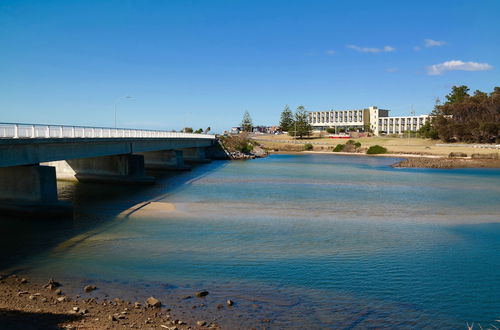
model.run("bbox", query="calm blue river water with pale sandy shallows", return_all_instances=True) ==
[0,154,500,329]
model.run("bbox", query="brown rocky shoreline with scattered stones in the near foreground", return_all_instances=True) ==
[0,275,223,330]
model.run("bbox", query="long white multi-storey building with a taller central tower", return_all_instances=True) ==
[308,107,429,135]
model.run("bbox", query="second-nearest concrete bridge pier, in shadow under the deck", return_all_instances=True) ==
[67,154,155,183]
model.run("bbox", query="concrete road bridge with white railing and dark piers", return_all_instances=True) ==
[0,123,227,215]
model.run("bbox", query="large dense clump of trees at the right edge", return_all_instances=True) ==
[426,86,500,143]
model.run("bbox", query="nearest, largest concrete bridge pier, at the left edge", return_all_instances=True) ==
[0,165,72,216]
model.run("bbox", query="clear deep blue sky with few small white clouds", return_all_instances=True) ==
[0,0,500,132]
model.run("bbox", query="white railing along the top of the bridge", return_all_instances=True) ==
[0,123,215,139]
